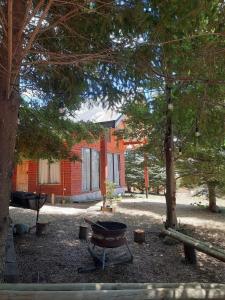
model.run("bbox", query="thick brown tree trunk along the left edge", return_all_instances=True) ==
[0,0,27,282]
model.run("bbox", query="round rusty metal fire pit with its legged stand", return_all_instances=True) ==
[86,219,133,269]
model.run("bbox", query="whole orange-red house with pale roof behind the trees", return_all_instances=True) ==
[13,107,125,201]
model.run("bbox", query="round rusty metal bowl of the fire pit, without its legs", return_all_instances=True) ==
[91,221,127,248]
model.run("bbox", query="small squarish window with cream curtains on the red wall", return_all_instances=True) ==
[39,159,60,184]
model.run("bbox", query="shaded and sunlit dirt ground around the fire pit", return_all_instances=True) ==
[10,191,225,283]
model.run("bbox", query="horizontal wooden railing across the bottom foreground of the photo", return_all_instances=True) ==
[0,283,225,300]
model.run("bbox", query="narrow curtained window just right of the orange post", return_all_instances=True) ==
[107,153,120,186]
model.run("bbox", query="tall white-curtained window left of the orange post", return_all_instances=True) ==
[82,148,99,192]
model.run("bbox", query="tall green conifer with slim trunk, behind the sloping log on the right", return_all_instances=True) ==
[122,1,225,227]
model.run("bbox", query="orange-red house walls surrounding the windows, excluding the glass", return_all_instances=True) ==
[12,124,125,200]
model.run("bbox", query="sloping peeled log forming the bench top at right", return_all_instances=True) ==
[164,228,225,262]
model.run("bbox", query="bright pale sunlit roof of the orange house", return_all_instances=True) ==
[75,104,123,127]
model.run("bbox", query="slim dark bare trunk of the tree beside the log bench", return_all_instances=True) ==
[164,85,177,228]
